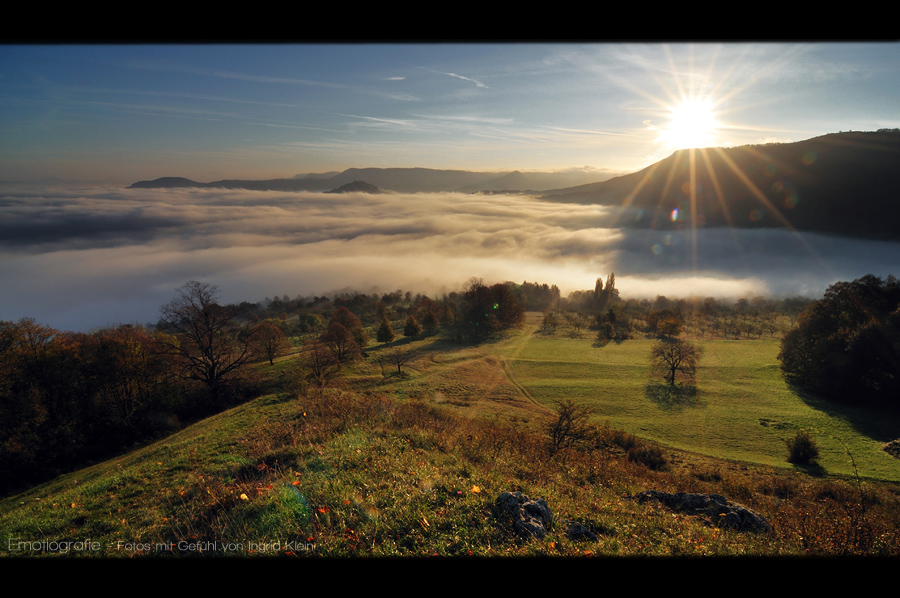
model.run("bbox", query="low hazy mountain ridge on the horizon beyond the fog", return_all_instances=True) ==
[129,168,612,193]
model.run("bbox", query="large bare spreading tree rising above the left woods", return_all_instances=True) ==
[159,280,254,401]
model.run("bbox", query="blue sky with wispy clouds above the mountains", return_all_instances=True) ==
[7,42,900,184]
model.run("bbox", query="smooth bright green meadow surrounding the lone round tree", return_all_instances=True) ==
[510,335,900,481]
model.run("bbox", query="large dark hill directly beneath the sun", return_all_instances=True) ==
[542,130,900,240]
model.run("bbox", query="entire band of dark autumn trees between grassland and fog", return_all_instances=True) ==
[8,274,880,493]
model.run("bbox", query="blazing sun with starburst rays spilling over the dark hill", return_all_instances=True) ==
[600,46,832,282]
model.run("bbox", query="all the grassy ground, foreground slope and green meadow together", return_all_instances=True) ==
[0,314,900,558]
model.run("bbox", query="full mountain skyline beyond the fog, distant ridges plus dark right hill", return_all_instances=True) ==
[130,129,900,241]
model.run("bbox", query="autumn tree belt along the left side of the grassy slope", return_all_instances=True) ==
[0,279,525,493]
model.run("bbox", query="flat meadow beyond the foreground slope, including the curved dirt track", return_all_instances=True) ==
[359,314,900,481]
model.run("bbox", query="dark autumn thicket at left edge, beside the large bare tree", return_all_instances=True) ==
[0,318,180,491]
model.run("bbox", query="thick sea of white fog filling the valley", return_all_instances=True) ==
[0,186,900,331]
